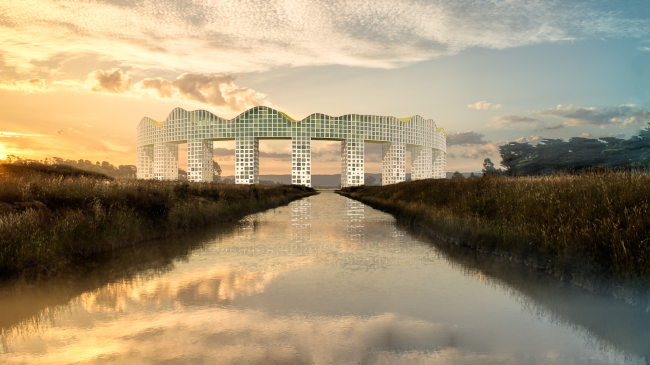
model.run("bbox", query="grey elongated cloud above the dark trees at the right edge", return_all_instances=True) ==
[534,104,650,128]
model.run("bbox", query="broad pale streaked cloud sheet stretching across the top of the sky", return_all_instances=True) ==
[0,0,650,73]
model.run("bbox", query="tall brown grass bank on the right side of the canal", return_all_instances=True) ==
[341,171,650,280]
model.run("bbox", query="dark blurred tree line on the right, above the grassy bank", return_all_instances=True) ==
[483,123,650,176]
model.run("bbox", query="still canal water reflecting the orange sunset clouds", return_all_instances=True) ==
[0,193,650,364]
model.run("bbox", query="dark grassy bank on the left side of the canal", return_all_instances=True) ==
[0,165,316,280]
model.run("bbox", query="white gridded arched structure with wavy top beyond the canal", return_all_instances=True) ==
[137,106,446,187]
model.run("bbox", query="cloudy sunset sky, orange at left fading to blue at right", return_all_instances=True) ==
[0,0,650,175]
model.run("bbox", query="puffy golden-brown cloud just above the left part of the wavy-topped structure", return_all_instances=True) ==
[136,73,267,111]
